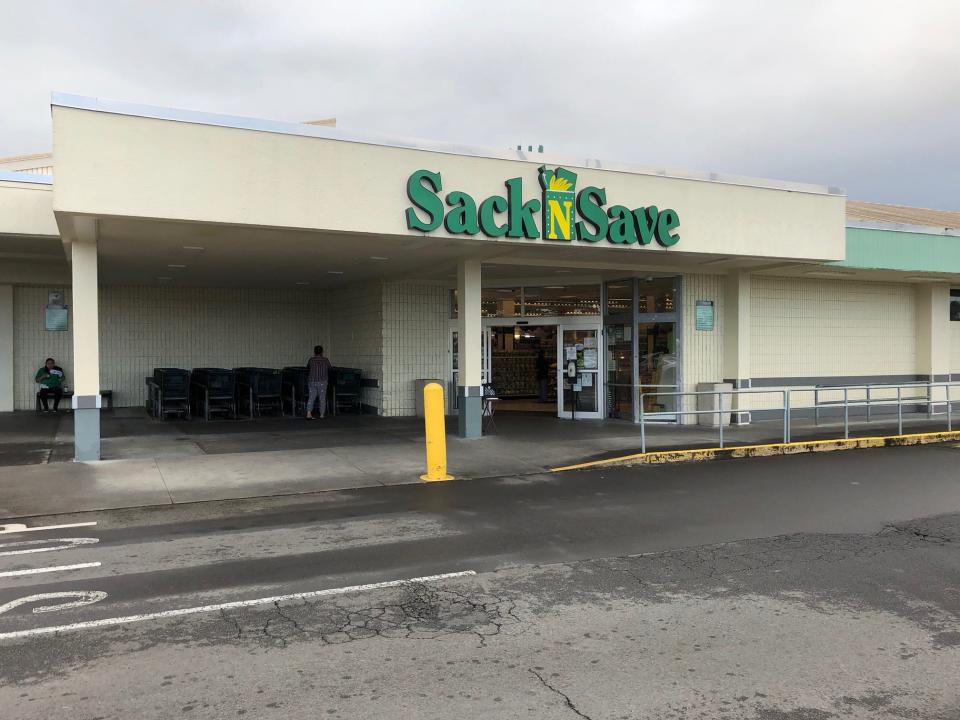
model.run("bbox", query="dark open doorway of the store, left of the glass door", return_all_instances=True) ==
[488,323,557,414]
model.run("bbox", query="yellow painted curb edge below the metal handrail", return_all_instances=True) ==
[550,430,960,472]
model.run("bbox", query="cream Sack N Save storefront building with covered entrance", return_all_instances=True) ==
[0,95,960,459]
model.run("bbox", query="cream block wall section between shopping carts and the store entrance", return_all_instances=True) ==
[383,281,450,416]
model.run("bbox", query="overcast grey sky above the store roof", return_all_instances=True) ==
[0,0,960,209]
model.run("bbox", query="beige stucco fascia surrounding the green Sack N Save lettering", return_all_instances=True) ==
[53,106,845,259]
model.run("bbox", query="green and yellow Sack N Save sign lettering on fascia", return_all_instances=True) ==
[405,166,680,247]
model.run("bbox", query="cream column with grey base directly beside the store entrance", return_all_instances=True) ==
[457,260,483,438]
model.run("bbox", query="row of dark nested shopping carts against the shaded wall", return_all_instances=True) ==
[145,366,362,420]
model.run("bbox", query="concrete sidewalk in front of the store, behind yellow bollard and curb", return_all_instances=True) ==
[0,408,943,518]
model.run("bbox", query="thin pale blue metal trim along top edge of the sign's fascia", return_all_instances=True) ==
[50,92,846,196]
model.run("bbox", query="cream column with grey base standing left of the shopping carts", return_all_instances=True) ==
[70,242,100,461]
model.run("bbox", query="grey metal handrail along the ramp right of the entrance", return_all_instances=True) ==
[639,382,960,452]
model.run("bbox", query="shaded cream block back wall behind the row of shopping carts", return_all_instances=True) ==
[14,286,329,409]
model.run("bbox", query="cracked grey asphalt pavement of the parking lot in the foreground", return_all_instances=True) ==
[0,446,960,720]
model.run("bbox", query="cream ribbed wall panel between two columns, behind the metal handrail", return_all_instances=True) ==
[750,275,916,378]
